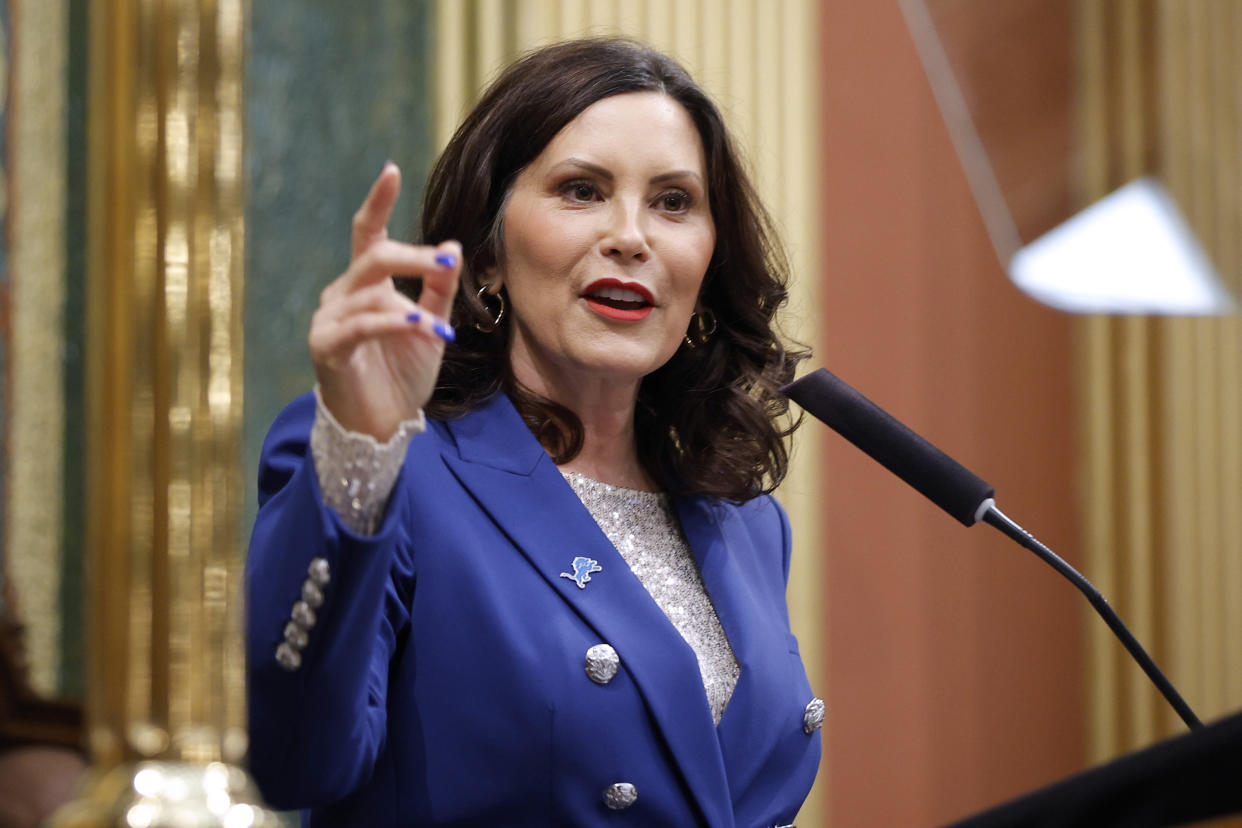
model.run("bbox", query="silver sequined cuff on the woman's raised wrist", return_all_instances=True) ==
[311,385,427,535]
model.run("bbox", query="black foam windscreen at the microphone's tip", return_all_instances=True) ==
[781,369,996,526]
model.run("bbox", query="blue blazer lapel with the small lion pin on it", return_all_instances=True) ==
[445,395,733,826]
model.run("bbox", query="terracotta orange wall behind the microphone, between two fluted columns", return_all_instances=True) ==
[807,0,1087,828]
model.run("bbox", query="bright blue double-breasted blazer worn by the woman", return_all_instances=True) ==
[246,395,820,828]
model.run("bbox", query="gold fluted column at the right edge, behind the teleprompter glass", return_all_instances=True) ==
[1078,0,1242,761]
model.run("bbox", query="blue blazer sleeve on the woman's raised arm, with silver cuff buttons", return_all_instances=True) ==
[246,395,414,808]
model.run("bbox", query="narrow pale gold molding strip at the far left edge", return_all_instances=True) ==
[4,0,68,696]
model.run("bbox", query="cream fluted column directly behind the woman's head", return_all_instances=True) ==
[433,0,831,826]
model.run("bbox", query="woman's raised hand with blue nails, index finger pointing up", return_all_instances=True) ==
[308,161,462,441]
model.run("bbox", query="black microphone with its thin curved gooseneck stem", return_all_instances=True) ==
[781,367,1203,730]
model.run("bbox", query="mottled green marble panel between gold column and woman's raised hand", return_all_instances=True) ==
[245,0,433,531]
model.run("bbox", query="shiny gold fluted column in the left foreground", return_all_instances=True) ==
[55,0,272,828]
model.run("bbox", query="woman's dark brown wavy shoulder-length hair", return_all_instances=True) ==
[421,38,807,500]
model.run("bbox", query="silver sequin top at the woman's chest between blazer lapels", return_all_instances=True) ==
[561,472,740,724]
